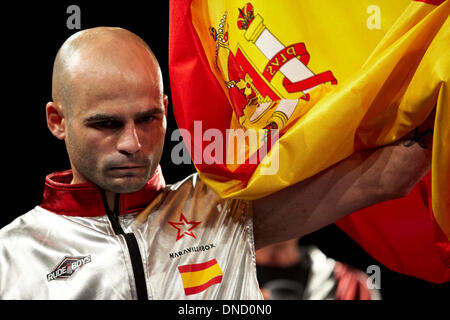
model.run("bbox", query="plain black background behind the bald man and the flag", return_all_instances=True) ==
[0,1,450,300]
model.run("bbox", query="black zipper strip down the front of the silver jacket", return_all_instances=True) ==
[100,190,148,300]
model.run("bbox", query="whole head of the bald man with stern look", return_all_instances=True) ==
[46,27,168,193]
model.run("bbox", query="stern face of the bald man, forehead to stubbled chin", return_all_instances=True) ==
[65,55,167,193]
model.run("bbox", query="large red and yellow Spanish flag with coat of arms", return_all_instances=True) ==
[169,0,450,282]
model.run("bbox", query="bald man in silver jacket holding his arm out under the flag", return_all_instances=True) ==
[0,27,431,299]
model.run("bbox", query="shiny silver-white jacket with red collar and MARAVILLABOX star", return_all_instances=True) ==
[0,171,262,299]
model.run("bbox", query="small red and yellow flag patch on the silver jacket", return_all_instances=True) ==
[178,259,222,296]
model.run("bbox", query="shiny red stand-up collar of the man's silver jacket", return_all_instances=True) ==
[41,166,166,217]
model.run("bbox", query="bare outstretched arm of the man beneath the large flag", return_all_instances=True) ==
[253,115,434,249]
